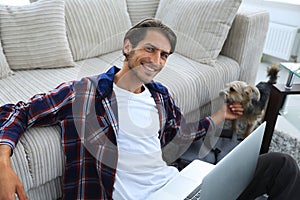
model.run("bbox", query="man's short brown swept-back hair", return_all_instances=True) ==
[123,18,177,54]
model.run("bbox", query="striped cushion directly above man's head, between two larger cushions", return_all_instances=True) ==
[127,0,159,24]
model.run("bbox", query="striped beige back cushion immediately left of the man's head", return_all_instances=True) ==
[65,0,131,61]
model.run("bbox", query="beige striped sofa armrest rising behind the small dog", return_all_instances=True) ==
[221,7,269,84]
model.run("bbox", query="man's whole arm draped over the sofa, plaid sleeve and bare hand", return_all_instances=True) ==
[0,80,73,200]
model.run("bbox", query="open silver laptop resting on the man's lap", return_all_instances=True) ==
[148,122,266,200]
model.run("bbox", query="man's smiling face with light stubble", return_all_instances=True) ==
[128,30,171,83]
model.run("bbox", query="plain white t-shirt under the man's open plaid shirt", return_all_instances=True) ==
[113,84,178,200]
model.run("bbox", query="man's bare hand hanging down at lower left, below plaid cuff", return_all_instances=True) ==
[0,145,28,200]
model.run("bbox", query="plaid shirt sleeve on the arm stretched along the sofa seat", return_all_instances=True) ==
[0,82,74,150]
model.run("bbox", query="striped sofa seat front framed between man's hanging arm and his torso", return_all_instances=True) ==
[20,126,65,187]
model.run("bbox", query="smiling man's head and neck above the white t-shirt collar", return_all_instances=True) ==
[114,24,176,93]
